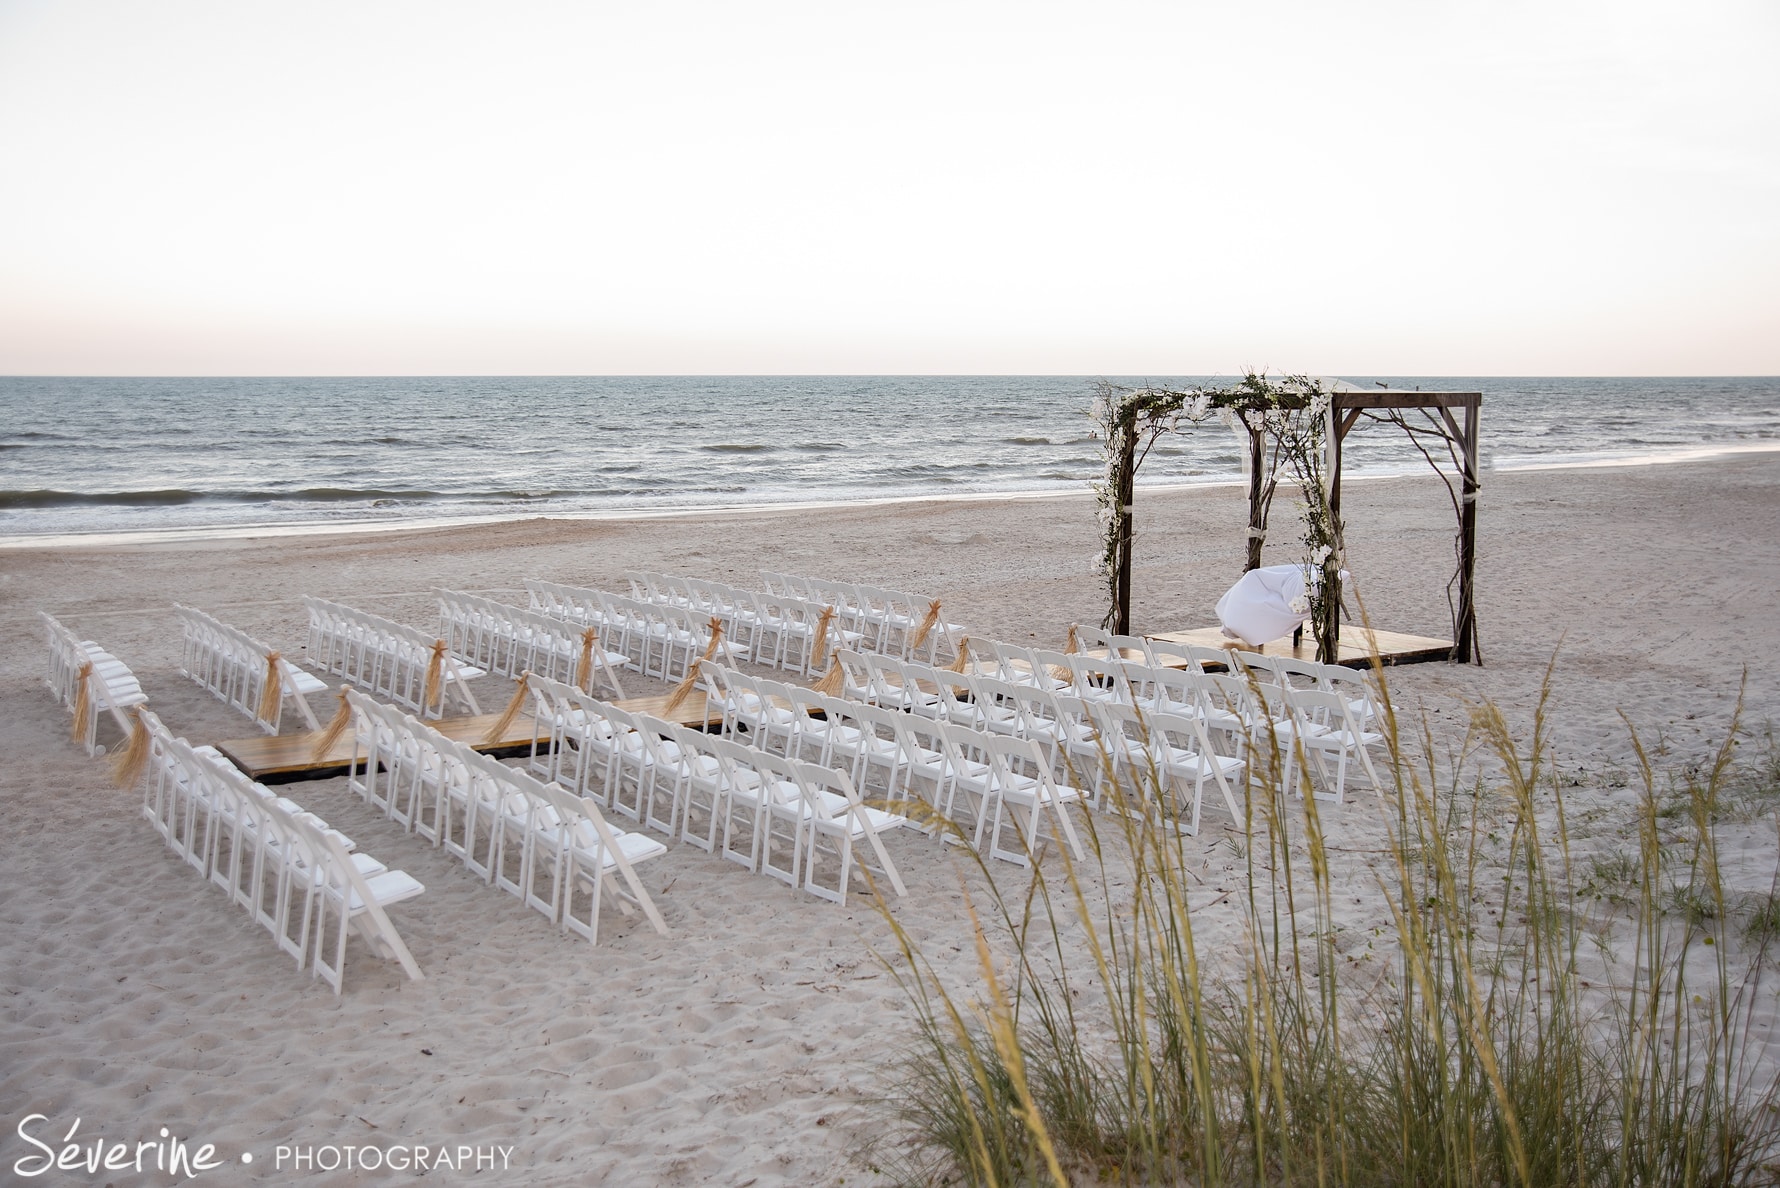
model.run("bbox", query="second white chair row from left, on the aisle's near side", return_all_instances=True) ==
[347,691,668,944]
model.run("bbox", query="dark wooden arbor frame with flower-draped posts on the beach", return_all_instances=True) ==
[1098,376,1483,664]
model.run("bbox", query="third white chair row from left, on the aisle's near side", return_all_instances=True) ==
[529,663,906,903]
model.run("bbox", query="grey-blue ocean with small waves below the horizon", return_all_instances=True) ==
[0,376,1780,538]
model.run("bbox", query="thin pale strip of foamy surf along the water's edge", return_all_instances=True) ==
[0,442,1780,552]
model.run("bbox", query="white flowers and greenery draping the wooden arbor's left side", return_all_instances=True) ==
[1088,372,1346,663]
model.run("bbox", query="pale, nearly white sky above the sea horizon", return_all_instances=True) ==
[0,0,1780,376]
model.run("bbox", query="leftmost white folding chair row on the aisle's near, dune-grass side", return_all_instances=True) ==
[141,711,425,996]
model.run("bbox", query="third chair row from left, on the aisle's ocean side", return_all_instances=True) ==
[303,595,482,718]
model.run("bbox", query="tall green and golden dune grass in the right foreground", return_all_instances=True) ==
[876,666,1780,1186]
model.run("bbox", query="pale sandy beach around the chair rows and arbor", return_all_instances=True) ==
[0,452,1780,1184]
